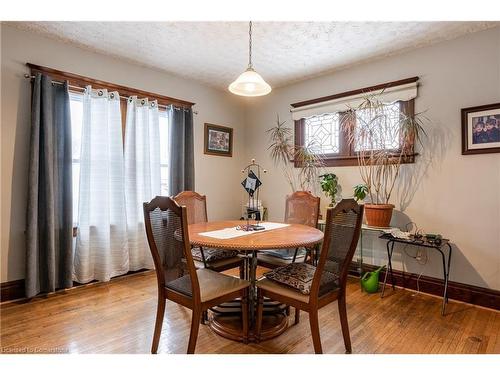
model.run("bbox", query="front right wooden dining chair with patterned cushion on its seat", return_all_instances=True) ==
[256,199,363,354]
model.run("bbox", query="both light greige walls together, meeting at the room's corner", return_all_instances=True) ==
[0,24,500,290]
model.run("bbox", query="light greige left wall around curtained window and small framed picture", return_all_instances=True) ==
[0,24,246,282]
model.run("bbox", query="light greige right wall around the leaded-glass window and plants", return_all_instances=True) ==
[246,28,500,290]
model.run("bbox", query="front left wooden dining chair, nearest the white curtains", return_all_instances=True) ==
[144,197,250,354]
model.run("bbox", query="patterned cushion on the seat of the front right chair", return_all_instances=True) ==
[264,263,339,295]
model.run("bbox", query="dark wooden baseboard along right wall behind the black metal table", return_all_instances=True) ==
[351,263,500,310]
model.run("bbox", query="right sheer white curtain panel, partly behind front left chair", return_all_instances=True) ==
[125,97,161,271]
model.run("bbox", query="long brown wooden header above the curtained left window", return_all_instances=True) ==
[26,63,195,108]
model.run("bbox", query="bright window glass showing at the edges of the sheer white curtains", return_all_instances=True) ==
[69,92,172,227]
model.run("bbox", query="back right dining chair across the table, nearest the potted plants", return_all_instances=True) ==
[257,191,320,269]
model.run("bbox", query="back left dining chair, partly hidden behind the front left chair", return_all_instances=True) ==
[174,191,245,279]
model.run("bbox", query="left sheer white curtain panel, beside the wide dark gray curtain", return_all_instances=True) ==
[74,86,129,283]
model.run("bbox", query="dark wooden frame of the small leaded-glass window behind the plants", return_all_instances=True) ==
[291,77,418,168]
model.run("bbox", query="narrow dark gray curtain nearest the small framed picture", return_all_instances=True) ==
[168,107,194,196]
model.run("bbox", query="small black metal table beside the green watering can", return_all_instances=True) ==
[379,234,452,315]
